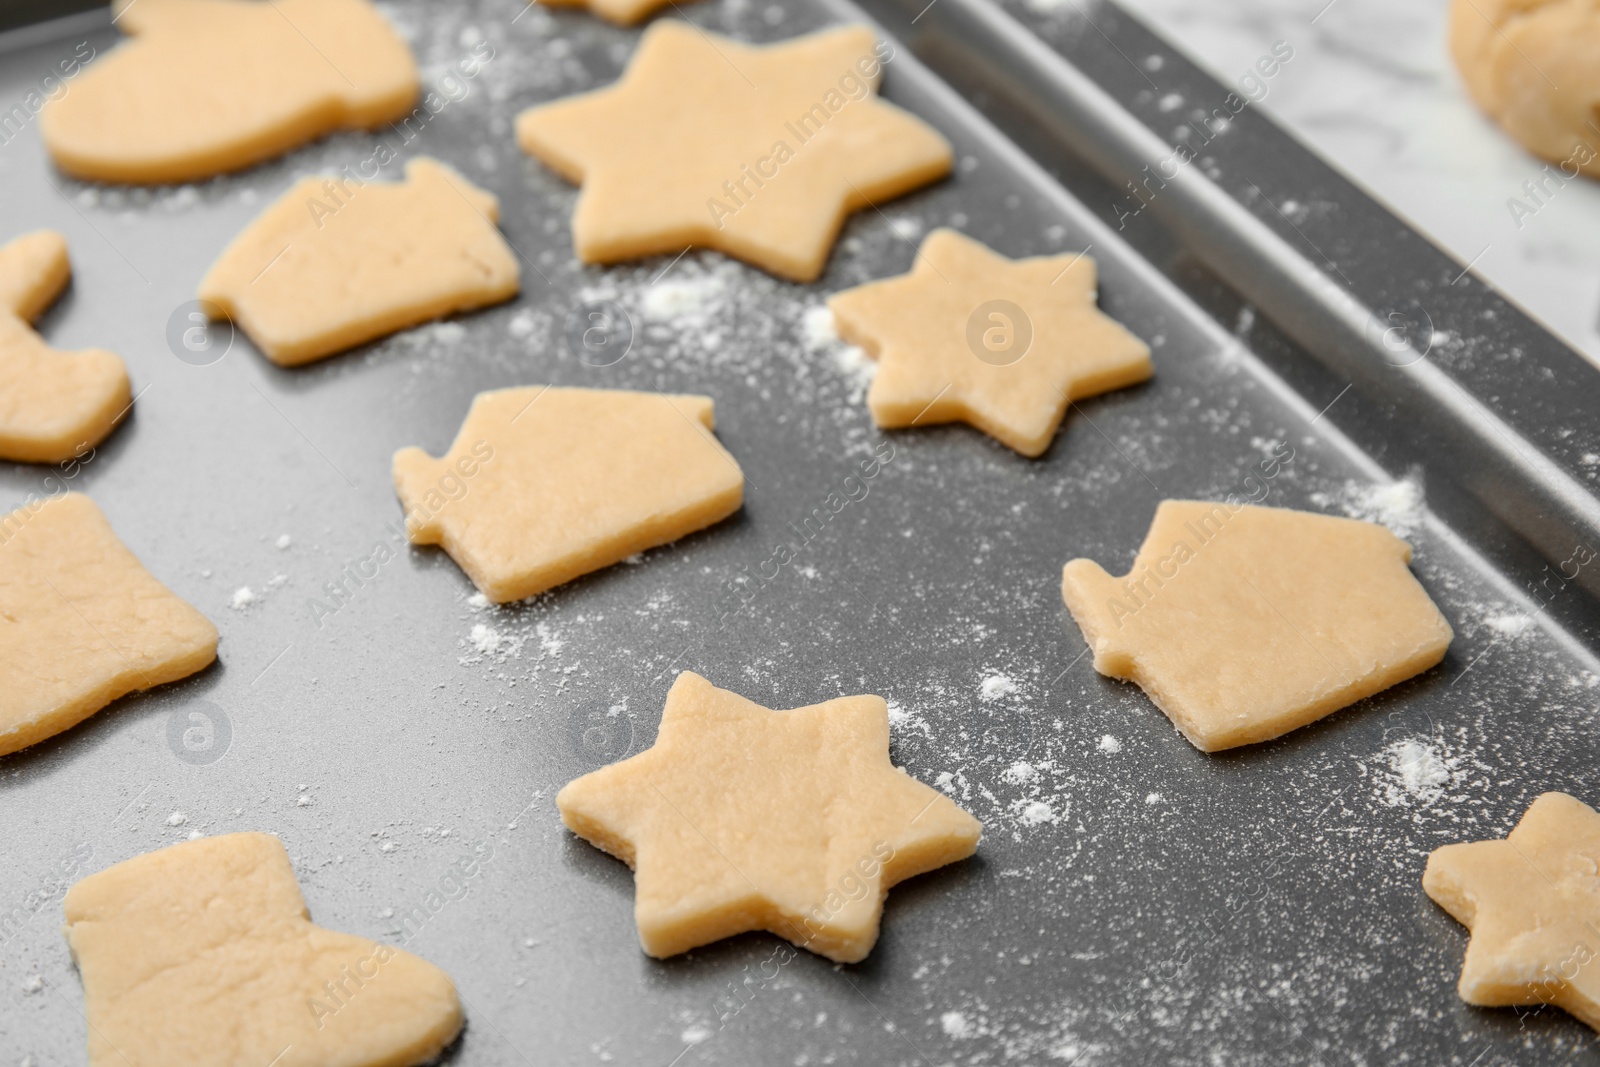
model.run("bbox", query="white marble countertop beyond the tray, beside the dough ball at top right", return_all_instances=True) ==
[1122,0,1600,363]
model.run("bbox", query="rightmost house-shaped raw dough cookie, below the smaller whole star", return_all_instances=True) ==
[1061,501,1451,752]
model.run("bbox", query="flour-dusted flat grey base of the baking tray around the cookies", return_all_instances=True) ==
[0,0,1600,1067]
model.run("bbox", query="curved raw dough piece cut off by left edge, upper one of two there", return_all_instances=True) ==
[0,230,133,462]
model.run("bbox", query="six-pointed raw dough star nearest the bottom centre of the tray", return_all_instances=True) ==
[555,672,982,963]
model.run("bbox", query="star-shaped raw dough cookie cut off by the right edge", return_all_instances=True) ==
[1422,793,1600,1030]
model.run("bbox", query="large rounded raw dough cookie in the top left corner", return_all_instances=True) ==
[38,0,418,182]
